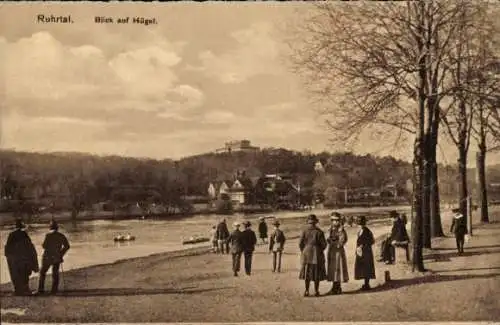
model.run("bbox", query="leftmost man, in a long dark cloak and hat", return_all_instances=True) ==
[5,220,38,296]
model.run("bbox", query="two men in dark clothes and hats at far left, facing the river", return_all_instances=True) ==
[5,220,70,296]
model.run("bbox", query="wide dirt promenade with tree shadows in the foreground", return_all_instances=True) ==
[1,210,500,322]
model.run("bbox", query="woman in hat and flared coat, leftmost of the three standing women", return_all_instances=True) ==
[299,214,327,297]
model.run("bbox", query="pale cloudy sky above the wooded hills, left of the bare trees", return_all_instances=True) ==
[0,2,500,163]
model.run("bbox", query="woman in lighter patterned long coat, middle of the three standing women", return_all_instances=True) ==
[326,212,349,295]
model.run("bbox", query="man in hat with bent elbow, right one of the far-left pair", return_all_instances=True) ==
[38,220,70,294]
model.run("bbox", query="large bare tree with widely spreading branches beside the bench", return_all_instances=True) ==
[292,1,478,270]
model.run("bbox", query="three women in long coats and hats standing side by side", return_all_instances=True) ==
[299,212,375,297]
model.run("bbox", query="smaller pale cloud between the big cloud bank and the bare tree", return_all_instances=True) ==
[194,23,280,83]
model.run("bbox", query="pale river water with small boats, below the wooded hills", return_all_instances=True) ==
[0,207,408,283]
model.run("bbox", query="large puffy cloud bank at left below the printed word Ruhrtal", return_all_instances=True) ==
[0,32,204,122]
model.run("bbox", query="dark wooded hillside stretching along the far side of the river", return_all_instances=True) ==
[0,148,500,214]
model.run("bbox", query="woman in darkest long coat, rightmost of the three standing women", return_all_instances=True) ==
[354,216,375,290]
